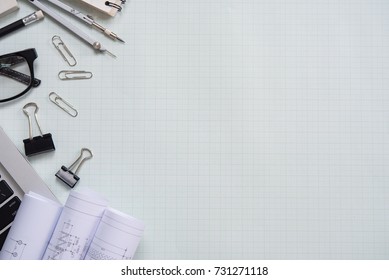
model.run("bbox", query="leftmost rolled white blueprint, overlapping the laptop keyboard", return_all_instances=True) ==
[0,192,62,260]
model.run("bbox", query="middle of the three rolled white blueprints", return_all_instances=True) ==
[43,189,108,260]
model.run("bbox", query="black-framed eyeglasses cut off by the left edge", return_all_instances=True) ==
[0,48,41,103]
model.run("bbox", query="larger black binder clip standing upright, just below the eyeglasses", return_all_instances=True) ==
[23,102,55,156]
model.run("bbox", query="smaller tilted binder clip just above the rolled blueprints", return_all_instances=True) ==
[55,148,93,188]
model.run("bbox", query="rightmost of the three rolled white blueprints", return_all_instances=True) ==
[85,208,145,260]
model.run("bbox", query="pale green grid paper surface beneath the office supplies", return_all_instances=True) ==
[0,0,389,259]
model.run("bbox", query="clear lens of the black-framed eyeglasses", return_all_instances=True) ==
[0,55,31,100]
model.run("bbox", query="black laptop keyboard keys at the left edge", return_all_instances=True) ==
[0,175,21,250]
